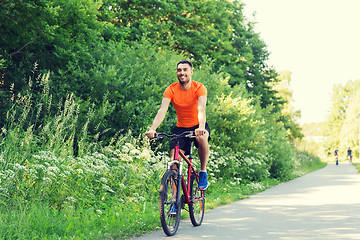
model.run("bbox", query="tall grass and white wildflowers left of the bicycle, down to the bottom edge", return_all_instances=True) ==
[0,74,162,239]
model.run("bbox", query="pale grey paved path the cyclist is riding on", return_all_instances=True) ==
[134,163,360,240]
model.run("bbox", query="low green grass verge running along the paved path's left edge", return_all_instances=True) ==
[0,159,323,239]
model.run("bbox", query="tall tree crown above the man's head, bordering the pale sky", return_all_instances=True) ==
[100,0,282,110]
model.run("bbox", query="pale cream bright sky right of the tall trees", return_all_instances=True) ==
[242,0,360,124]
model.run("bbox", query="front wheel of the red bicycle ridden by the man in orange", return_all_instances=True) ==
[159,170,181,236]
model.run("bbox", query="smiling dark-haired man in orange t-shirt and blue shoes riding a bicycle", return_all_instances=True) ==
[146,60,210,189]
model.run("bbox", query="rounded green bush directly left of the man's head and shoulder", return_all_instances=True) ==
[60,40,180,138]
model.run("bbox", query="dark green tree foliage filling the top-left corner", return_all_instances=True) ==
[0,0,107,125]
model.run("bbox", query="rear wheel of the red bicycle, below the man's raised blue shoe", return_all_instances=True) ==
[189,174,205,227]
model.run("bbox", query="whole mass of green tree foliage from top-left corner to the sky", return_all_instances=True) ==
[0,0,296,147]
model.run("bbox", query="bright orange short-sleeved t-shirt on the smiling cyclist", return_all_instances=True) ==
[164,81,207,128]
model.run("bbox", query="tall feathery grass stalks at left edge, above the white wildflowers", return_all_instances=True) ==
[0,73,78,169]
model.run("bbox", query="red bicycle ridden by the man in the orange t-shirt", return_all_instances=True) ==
[156,131,205,236]
